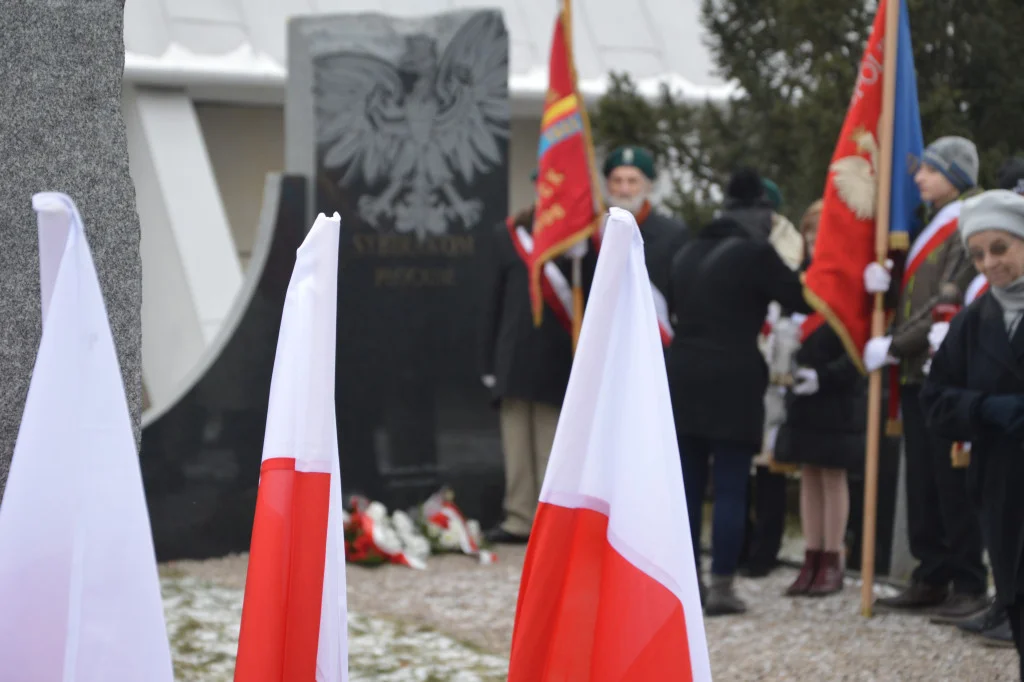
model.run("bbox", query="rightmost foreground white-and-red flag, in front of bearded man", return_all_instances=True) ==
[508,208,711,682]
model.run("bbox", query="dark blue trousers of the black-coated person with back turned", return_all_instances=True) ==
[679,435,754,576]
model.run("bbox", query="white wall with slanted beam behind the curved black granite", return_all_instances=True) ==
[122,86,242,404]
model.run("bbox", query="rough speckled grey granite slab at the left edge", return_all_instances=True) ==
[0,0,142,497]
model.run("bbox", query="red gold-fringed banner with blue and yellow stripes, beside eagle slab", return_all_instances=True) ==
[529,0,604,325]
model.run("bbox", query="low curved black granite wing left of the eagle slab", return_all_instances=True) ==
[141,176,309,561]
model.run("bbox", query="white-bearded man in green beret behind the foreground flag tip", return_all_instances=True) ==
[602,145,689,348]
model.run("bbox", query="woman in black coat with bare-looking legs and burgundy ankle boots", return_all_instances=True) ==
[775,201,867,596]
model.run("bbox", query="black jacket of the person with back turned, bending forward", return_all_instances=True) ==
[668,219,810,452]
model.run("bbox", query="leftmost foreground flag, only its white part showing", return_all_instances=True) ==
[0,193,174,682]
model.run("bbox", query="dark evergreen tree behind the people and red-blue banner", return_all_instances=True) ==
[593,0,1024,224]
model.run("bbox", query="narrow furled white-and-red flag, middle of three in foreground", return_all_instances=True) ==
[234,213,348,682]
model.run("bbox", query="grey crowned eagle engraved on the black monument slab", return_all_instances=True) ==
[314,12,509,239]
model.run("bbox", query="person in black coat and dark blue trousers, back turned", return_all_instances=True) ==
[667,175,809,615]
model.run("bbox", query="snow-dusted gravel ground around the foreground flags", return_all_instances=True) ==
[164,546,1017,682]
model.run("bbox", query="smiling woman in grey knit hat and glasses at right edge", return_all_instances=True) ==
[921,189,1024,679]
